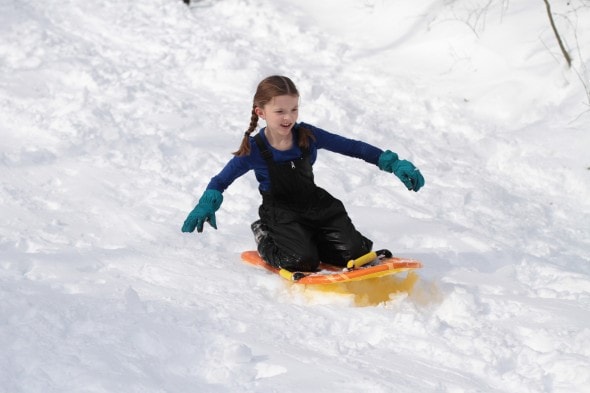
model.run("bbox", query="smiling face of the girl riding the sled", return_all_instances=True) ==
[255,95,299,136]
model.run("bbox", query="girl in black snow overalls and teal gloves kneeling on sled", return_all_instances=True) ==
[182,75,424,271]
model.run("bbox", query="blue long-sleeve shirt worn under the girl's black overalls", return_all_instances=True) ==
[207,123,383,192]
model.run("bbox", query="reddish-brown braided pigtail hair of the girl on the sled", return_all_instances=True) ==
[233,75,315,157]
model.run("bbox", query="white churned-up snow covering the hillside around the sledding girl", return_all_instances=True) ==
[0,0,590,393]
